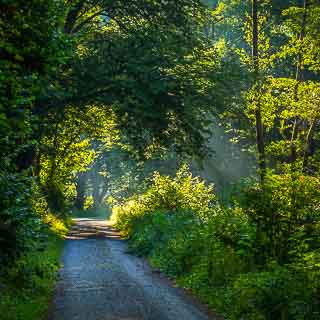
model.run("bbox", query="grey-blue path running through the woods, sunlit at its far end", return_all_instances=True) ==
[49,219,214,320]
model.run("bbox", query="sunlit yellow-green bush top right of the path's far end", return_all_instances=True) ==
[113,166,215,236]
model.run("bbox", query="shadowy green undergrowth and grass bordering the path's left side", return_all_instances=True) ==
[0,175,71,320]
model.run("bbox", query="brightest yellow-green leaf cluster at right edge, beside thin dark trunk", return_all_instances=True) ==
[246,77,320,164]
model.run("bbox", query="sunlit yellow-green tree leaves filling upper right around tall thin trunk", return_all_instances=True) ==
[212,1,319,172]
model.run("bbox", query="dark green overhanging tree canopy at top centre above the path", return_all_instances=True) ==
[62,0,219,156]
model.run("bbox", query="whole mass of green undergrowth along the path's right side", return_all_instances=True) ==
[113,169,320,320]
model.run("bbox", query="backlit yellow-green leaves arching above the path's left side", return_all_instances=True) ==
[40,106,119,209]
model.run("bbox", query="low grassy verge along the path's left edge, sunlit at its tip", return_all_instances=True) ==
[0,220,67,320]
